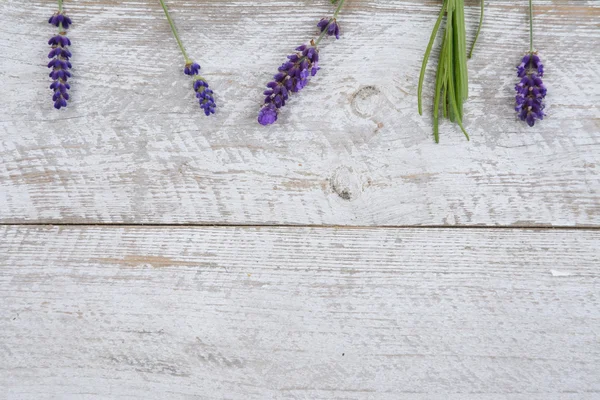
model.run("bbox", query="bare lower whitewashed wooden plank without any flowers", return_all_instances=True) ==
[0,226,600,400]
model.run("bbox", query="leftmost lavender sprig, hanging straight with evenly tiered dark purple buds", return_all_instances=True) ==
[48,0,72,110]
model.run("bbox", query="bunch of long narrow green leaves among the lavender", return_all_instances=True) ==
[418,0,483,143]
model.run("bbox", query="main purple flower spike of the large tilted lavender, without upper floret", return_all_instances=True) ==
[258,44,319,125]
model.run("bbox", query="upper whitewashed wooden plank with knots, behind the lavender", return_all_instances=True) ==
[0,0,600,226]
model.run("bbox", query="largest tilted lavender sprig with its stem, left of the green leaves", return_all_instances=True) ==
[258,0,345,125]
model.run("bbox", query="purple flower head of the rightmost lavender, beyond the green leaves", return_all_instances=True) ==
[515,53,546,126]
